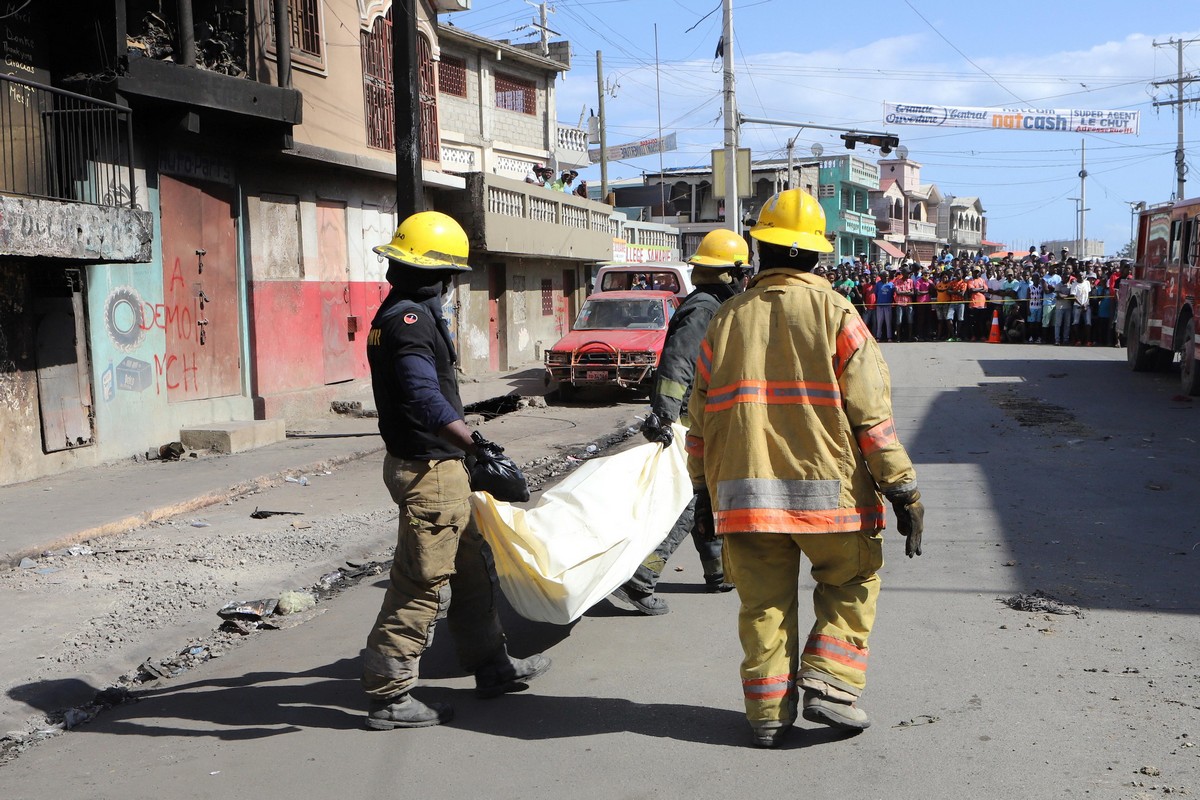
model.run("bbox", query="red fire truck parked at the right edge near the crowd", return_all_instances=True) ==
[1116,198,1200,396]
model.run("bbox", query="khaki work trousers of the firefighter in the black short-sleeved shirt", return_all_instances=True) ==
[362,455,504,698]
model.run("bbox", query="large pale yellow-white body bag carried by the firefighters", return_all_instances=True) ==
[472,426,691,625]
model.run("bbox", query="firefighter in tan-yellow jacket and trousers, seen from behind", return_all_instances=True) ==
[688,190,924,747]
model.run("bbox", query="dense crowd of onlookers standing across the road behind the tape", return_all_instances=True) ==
[814,247,1129,347]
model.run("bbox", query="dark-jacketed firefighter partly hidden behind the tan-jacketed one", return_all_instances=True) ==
[613,228,750,615]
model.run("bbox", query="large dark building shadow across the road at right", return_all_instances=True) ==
[895,348,1200,614]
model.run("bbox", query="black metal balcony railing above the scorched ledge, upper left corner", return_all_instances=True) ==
[0,76,137,207]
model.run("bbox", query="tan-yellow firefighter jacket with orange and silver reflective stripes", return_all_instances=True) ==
[688,269,917,534]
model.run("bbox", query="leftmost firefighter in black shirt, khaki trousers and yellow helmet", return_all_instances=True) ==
[362,211,550,730]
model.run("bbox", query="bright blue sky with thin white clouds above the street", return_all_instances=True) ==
[442,0,1200,253]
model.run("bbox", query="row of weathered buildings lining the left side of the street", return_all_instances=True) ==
[0,0,657,483]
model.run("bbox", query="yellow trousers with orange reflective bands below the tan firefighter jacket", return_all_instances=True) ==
[722,531,883,724]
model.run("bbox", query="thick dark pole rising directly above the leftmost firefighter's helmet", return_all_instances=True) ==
[391,0,422,215]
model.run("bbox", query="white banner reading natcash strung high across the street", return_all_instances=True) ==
[883,103,1141,136]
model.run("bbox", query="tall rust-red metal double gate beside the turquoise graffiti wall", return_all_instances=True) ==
[158,175,241,403]
